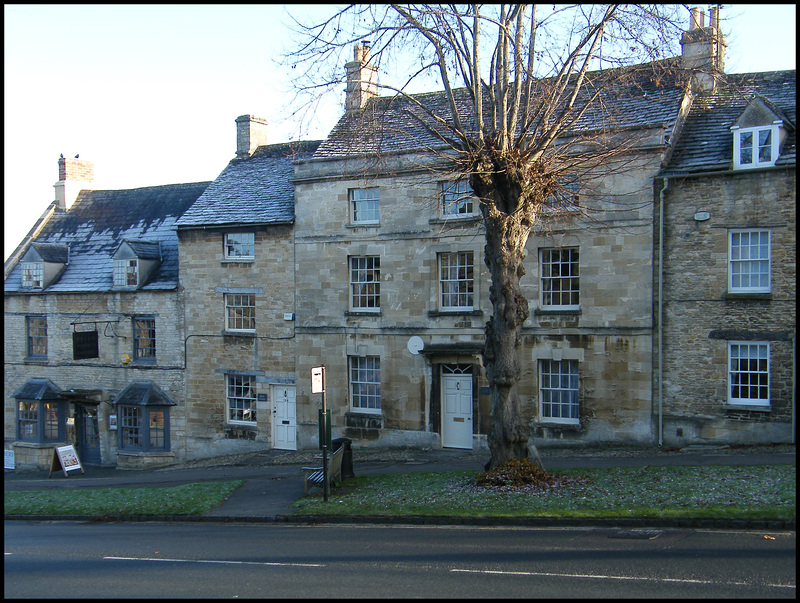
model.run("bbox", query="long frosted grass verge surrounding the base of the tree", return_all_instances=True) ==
[293,465,796,520]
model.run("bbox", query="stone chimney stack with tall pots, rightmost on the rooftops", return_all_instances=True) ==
[681,7,726,94]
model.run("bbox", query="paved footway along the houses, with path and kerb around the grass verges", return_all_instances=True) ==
[4,445,796,530]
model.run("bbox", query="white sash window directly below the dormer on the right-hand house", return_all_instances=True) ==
[728,230,772,293]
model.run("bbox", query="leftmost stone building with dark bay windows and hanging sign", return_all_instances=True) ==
[3,157,208,469]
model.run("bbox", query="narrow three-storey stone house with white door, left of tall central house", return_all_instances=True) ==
[177,125,319,458]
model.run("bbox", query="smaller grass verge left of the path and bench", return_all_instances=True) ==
[4,480,244,516]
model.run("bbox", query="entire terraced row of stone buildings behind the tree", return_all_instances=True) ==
[4,9,796,468]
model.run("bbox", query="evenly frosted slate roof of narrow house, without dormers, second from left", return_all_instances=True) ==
[177,141,319,229]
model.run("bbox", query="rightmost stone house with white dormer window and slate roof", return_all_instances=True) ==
[654,66,797,446]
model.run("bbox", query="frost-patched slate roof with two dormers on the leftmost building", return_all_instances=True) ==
[5,182,209,293]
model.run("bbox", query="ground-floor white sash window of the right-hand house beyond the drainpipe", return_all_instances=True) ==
[728,341,769,406]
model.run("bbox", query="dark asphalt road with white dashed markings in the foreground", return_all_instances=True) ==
[4,521,796,599]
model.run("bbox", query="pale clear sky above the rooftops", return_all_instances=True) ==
[4,4,796,258]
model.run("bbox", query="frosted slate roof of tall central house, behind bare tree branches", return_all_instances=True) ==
[314,59,686,159]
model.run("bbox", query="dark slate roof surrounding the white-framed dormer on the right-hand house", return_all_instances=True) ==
[663,70,797,175]
